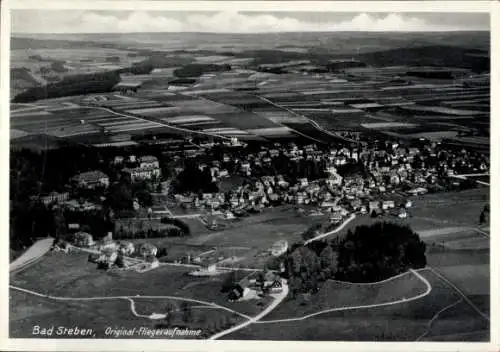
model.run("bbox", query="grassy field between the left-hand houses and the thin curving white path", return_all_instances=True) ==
[11,253,270,314]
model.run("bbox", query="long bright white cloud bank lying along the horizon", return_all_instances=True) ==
[12,11,485,33]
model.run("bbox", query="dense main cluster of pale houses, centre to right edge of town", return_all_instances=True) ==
[171,141,489,226]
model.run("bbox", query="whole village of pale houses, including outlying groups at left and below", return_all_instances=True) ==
[41,129,488,301]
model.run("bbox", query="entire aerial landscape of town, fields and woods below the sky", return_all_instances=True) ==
[9,9,490,341]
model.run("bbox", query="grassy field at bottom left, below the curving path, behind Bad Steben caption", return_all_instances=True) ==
[9,290,243,338]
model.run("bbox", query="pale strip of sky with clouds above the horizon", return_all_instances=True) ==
[11,10,490,34]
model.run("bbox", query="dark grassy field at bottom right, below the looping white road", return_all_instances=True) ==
[225,270,484,341]
